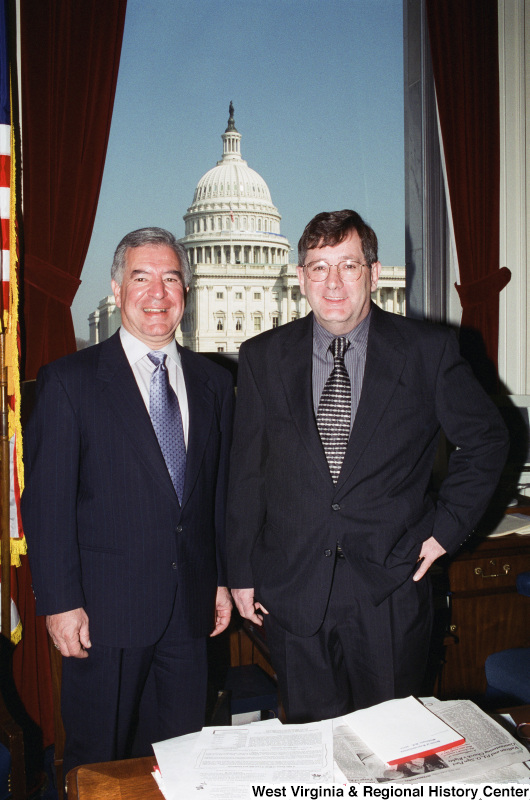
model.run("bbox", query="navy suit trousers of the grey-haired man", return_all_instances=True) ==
[61,592,204,775]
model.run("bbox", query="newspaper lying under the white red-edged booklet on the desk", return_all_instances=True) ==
[333,698,530,783]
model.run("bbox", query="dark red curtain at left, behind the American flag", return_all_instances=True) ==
[13,0,126,746]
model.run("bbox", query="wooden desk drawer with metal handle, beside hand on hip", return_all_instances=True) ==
[449,553,530,594]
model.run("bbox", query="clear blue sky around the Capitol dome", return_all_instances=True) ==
[72,0,405,338]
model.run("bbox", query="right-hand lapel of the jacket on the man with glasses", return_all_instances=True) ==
[337,305,406,490]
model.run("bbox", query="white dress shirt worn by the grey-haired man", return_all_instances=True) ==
[120,325,190,447]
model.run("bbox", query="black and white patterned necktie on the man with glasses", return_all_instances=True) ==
[317,336,351,483]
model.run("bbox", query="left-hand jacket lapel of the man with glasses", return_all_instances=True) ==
[278,313,331,481]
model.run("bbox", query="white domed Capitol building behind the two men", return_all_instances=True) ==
[88,104,405,352]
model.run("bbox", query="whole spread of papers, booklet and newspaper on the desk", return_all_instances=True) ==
[148,697,530,800]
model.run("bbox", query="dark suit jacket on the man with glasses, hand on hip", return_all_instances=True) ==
[227,306,507,636]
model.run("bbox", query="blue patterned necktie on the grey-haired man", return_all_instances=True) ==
[147,350,186,505]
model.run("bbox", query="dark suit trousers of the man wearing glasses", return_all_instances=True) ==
[264,558,432,722]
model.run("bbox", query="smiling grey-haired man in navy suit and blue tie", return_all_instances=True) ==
[22,228,233,774]
